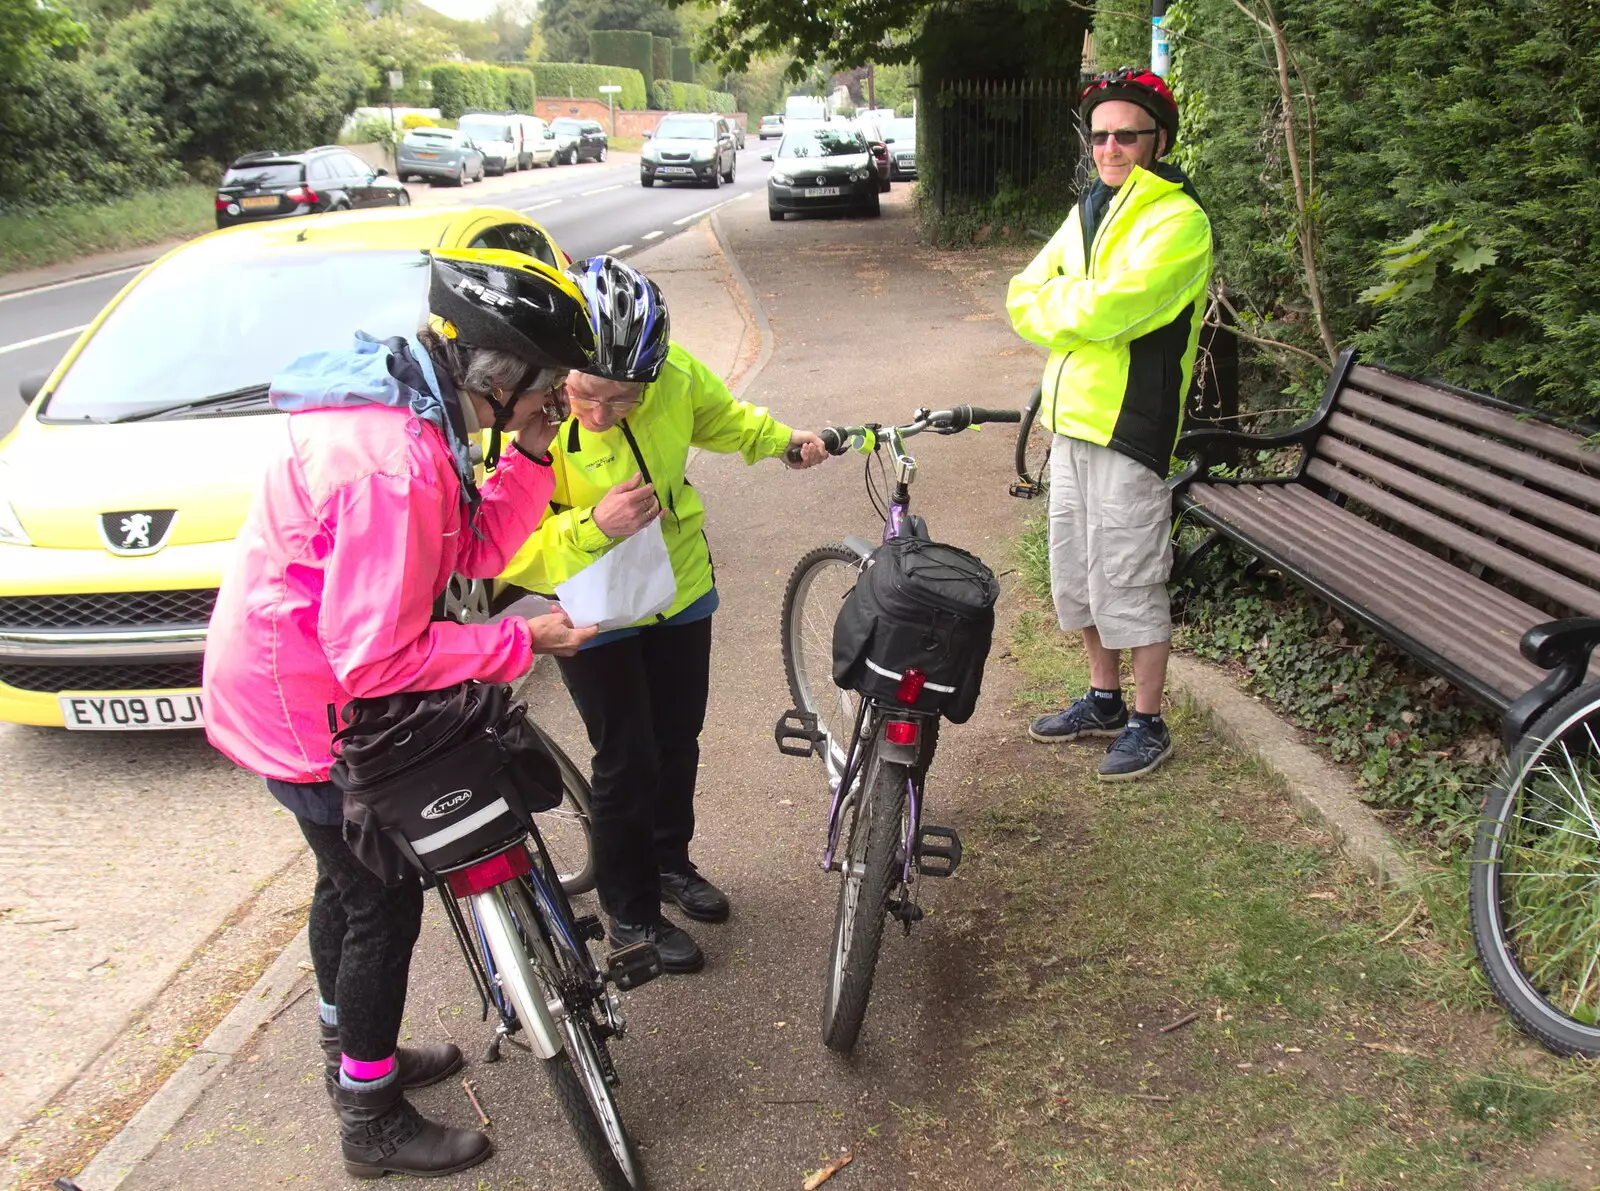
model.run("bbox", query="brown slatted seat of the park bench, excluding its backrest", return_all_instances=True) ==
[1192,485,1542,703]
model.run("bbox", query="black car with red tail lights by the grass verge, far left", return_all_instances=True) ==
[216,144,411,227]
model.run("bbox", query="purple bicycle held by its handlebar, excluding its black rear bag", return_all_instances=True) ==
[773,405,1021,1053]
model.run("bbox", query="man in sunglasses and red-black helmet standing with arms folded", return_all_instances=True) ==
[1006,67,1211,781]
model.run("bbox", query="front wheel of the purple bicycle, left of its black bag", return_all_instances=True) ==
[782,544,862,775]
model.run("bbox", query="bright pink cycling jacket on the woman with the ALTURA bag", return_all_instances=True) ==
[205,405,554,783]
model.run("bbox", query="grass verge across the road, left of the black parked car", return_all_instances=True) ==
[0,182,216,272]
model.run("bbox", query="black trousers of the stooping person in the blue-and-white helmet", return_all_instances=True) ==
[560,616,712,924]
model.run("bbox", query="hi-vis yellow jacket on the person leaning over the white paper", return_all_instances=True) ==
[502,344,790,623]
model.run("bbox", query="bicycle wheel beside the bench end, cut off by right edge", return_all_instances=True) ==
[1467,687,1600,1058]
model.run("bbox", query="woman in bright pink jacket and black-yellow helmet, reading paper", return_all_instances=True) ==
[205,251,594,1177]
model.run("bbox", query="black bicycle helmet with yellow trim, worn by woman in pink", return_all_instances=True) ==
[427,248,595,368]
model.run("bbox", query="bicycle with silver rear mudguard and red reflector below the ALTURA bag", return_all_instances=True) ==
[406,732,661,1191]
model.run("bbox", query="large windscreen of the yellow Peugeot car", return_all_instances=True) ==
[43,247,427,421]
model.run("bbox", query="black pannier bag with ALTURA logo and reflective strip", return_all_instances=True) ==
[330,682,562,885]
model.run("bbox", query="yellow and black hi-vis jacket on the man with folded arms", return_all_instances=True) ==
[1006,165,1211,477]
